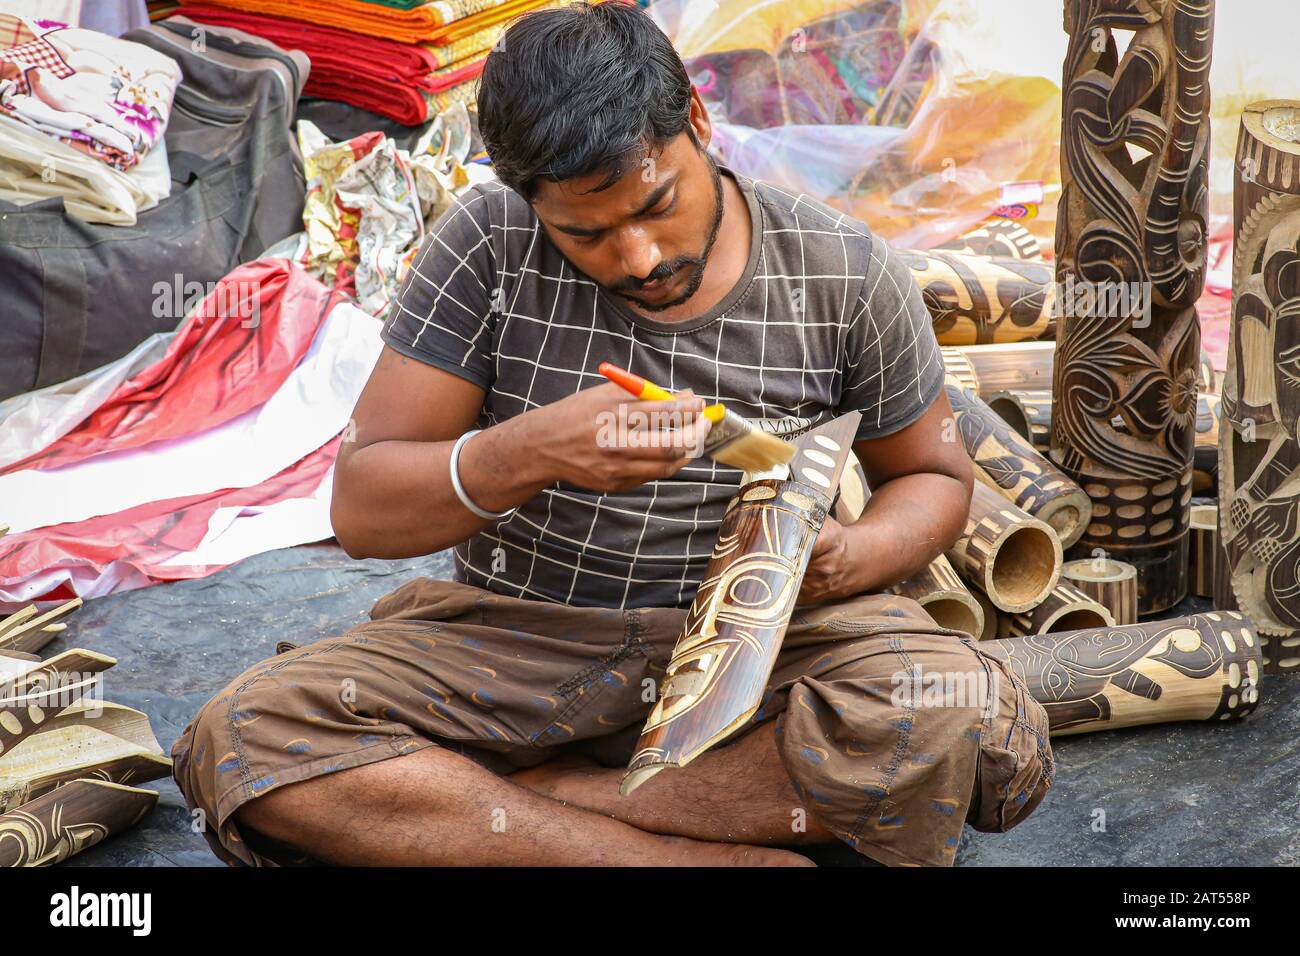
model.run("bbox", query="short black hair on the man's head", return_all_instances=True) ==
[478,0,694,200]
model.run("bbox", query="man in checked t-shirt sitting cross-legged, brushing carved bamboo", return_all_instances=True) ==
[174,3,1052,865]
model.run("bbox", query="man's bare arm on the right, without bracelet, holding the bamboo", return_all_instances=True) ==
[800,392,974,604]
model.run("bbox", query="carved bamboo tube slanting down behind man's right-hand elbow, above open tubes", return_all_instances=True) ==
[946,376,1092,548]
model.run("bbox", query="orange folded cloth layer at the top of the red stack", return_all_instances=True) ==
[182,0,542,44]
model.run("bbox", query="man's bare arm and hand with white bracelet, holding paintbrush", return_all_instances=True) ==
[330,349,709,558]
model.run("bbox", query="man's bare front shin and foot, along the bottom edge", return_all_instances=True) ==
[228,747,811,866]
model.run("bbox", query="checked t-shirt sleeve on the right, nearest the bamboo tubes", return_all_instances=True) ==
[839,235,944,441]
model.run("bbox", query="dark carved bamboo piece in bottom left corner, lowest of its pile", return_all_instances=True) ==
[0,779,159,866]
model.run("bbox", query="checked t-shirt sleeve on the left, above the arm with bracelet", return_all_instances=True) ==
[382,189,501,389]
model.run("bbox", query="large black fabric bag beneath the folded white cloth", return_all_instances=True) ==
[0,18,308,399]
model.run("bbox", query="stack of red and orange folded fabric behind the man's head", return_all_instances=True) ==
[174,0,558,126]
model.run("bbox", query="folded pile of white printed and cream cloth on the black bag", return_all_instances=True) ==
[0,14,181,222]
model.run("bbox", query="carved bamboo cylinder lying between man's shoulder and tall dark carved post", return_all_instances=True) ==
[898,250,1056,345]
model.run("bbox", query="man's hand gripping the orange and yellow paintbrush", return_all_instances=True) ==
[522,382,711,493]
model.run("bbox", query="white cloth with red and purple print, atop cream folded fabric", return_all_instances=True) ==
[0,14,181,170]
